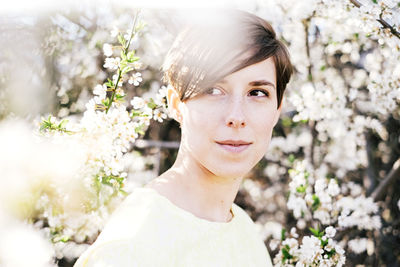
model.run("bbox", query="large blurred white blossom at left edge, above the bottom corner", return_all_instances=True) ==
[0,119,84,219]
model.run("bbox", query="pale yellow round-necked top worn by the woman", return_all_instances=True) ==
[74,188,272,267]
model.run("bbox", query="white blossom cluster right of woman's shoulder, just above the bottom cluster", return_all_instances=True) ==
[287,161,381,230]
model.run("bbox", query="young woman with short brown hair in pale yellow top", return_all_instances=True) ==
[75,10,292,267]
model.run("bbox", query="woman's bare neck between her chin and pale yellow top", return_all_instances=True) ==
[147,150,242,222]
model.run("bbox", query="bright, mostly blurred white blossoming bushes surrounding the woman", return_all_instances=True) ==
[0,0,400,267]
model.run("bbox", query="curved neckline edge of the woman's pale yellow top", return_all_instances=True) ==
[135,187,238,226]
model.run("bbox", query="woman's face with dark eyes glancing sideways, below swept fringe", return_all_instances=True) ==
[179,58,280,178]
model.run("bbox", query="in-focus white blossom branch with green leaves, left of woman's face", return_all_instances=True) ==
[38,17,167,247]
